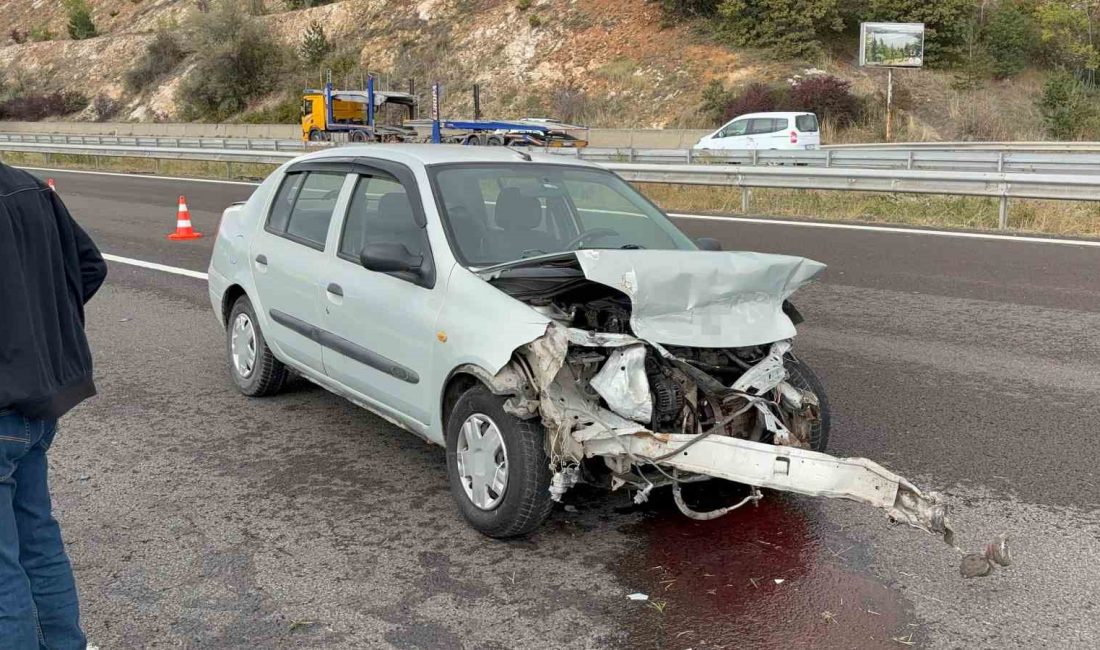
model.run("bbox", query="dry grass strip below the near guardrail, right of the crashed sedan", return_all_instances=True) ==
[636,183,1100,236]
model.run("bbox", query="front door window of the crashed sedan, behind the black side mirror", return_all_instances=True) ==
[340,174,428,263]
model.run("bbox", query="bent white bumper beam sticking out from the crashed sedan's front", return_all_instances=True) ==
[584,431,955,547]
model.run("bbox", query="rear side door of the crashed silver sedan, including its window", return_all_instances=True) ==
[249,170,347,372]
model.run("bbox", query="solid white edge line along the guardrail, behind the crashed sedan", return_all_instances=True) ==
[20,167,1100,246]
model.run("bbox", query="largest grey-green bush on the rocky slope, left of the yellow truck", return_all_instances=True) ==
[176,0,284,120]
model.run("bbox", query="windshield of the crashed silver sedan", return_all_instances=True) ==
[433,162,695,266]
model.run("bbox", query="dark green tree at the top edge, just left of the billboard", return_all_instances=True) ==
[718,0,844,57]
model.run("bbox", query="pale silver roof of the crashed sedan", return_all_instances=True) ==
[299,144,601,168]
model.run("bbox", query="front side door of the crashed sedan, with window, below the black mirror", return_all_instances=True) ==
[321,162,443,425]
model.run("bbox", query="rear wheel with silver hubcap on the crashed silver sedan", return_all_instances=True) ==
[226,296,288,397]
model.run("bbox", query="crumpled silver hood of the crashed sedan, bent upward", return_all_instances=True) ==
[576,249,825,348]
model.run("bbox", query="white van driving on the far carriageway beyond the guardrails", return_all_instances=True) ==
[692,113,822,151]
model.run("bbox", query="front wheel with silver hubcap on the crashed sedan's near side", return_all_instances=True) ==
[447,385,553,538]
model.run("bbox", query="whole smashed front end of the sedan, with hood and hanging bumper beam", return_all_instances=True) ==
[481,250,1009,576]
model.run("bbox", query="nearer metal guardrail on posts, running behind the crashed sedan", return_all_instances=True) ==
[0,141,1100,229]
